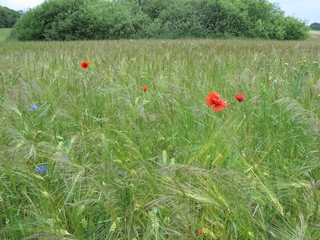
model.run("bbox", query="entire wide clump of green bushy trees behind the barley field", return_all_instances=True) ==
[11,0,309,41]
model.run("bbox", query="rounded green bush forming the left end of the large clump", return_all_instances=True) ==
[12,0,133,41]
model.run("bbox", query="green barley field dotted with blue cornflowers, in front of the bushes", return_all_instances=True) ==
[0,28,320,240]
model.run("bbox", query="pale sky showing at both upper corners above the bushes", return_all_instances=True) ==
[0,0,320,24]
